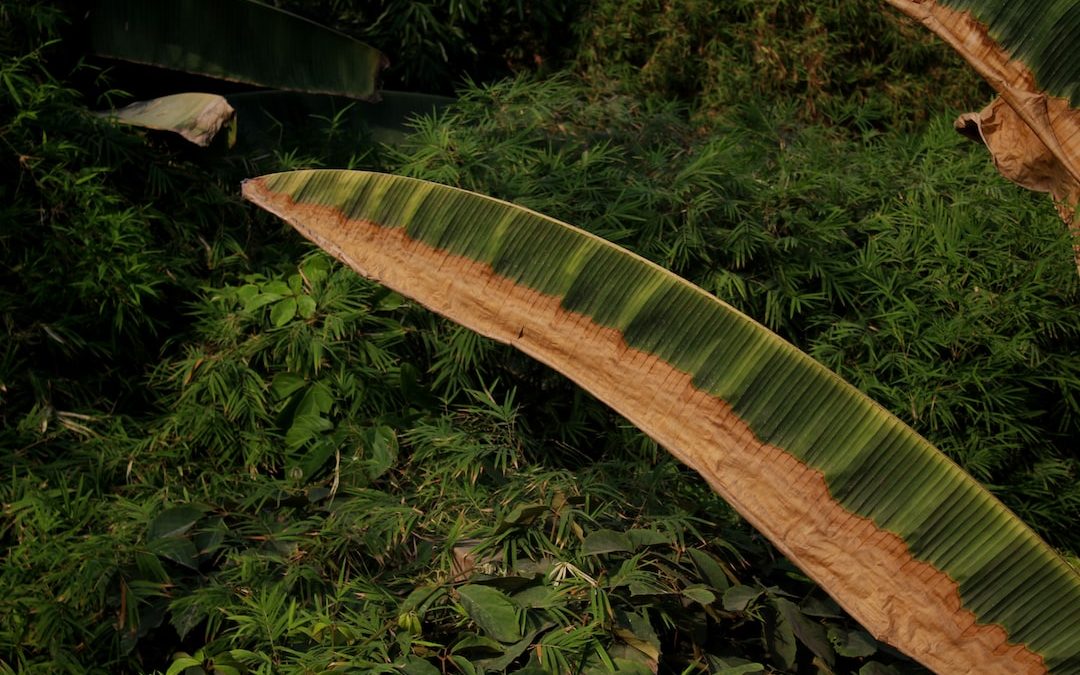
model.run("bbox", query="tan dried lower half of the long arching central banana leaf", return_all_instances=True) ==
[243,178,1047,675]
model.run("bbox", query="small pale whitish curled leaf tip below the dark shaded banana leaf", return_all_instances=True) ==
[98,93,237,148]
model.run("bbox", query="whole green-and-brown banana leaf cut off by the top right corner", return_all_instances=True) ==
[889,0,1080,257]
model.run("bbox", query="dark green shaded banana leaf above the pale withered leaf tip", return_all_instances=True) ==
[90,0,386,99]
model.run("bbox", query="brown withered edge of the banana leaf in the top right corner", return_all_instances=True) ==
[888,0,1080,272]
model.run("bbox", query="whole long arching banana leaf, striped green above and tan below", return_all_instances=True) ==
[243,171,1080,674]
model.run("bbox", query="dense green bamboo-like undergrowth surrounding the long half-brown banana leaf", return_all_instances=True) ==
[0,0,1080,674]
